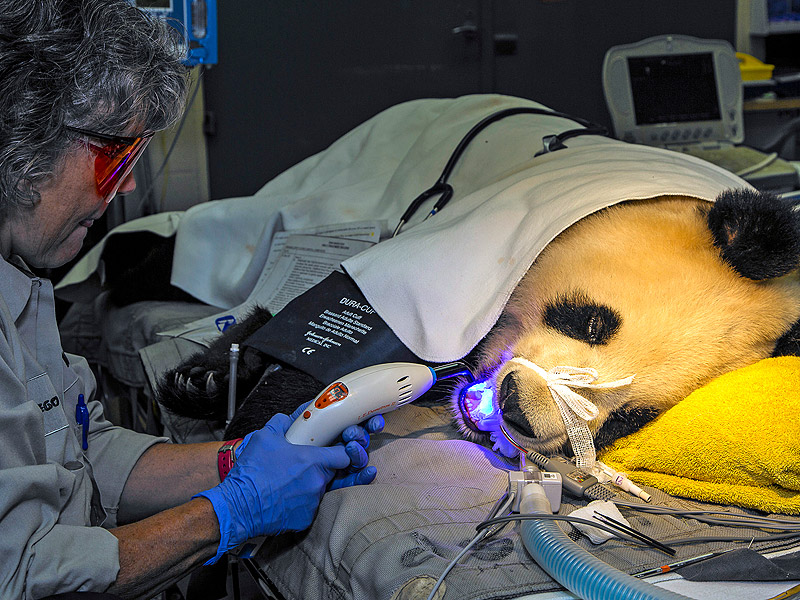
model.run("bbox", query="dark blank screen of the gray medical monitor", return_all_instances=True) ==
[628,52,721,125]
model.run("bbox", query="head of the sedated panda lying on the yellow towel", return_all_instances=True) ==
[453,190,800,453]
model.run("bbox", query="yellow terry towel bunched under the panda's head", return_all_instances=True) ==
[598,356,800,515]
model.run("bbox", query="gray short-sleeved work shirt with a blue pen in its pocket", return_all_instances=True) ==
[0,258,166,599]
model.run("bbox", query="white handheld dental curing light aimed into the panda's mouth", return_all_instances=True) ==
[286,363,471,446]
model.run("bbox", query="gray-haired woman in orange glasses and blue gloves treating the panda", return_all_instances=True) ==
[0,0,382,598]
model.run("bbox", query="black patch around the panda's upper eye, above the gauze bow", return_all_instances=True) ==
[544,293,622,346]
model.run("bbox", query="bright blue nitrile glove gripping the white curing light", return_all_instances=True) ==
[195,405,383,564]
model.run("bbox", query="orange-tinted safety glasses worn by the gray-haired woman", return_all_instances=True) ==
[67,126,153,202]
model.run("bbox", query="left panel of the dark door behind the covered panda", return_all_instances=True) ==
[204,0,488,198]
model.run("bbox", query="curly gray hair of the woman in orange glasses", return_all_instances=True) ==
[0,0,188,211]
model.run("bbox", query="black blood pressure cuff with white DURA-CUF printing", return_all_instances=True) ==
[243,271,423,382]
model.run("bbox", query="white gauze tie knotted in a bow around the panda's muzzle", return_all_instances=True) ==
[509,356,634,470]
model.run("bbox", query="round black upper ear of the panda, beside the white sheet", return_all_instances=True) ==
[707,189,800,281]
